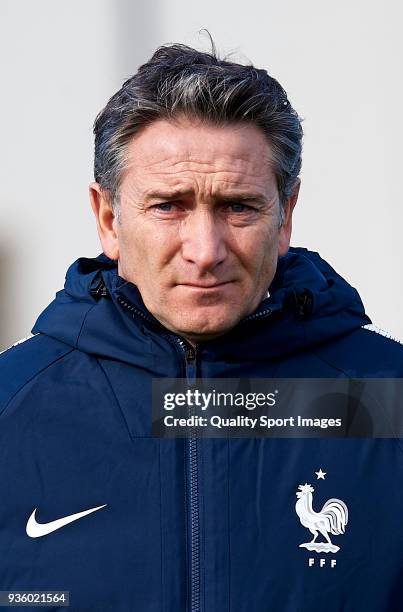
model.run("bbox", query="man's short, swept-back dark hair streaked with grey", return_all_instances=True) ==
[94,44,303,225]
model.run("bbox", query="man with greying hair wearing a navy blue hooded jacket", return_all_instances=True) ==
[0,45,403,612]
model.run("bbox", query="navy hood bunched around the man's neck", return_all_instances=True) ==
[32,248,371,366]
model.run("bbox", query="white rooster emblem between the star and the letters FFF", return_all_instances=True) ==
[295,483,348,553]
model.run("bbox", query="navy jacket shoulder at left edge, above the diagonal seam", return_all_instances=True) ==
[0,334,74,413]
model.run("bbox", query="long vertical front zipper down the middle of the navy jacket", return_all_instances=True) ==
[175,336,201,612]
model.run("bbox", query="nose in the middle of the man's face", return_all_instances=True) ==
[180,211,227,274]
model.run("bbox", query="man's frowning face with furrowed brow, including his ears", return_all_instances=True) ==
[92,118,296,341]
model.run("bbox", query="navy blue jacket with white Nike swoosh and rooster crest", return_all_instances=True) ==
[0,249,403,612]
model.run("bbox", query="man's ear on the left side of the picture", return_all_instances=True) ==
[89,183,119,259]
